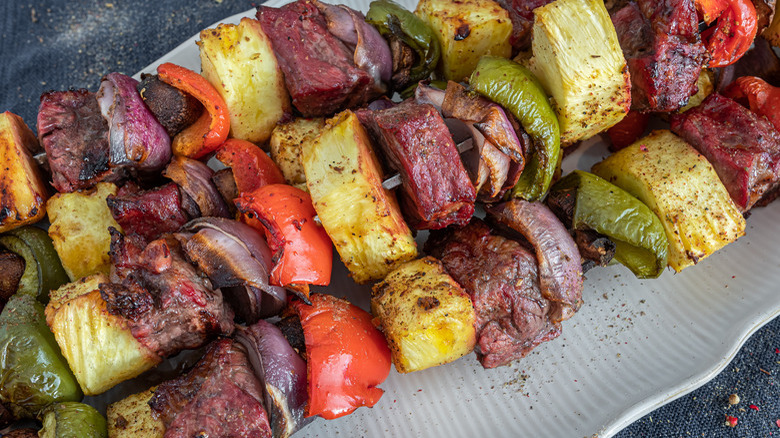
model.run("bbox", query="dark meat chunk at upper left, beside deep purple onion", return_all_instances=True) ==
[38,89,125,192]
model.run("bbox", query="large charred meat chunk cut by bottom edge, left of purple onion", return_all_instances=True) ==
[149,339,271,438]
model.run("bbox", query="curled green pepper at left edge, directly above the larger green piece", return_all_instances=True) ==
[0,226,69,304]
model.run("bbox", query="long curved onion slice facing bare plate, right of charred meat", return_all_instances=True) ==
[486,199,582,322]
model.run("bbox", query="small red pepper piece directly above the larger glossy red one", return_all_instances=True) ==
[217,138,284,194]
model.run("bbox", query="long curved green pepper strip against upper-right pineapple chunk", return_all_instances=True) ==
[469,56,561,201]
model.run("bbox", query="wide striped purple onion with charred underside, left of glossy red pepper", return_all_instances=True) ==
[177,217,287,323]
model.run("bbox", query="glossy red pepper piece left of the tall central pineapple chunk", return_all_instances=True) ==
[236,184,333,298]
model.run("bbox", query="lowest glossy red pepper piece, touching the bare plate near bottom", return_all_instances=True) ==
[291,294,390,420]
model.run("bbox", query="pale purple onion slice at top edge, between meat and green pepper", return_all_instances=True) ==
[315,1,393,93]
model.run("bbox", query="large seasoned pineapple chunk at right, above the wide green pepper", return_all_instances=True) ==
[593,130,745,272]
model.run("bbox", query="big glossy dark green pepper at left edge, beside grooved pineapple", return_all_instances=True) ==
[0,294,82,418]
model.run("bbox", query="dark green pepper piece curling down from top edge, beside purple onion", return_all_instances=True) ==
[366,0,441,83]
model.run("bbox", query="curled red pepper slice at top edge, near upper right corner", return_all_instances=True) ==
[696,0,758,68]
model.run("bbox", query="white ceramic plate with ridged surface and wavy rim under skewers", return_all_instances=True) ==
[137,0,780,438]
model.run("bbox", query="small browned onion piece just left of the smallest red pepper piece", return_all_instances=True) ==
[163,155,230,217]
